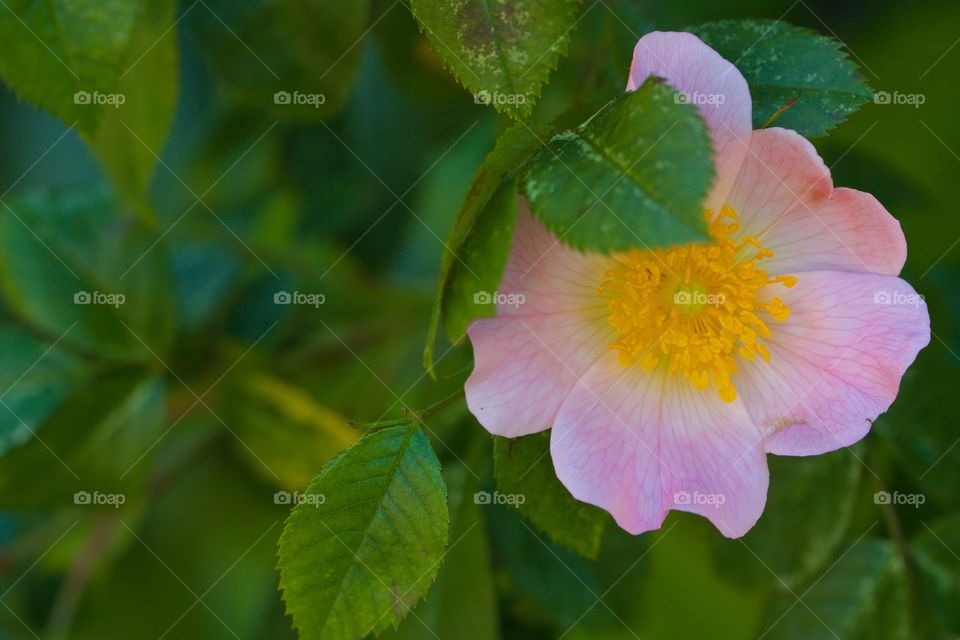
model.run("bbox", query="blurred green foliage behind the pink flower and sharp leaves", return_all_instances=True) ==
[0,0,960,640]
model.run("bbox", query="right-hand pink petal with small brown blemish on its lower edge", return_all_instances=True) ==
[734,271,930,456]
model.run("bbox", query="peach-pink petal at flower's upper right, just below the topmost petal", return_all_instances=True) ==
[727,128,907,275]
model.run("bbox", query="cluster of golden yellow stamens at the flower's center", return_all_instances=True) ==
[598,205,797,402]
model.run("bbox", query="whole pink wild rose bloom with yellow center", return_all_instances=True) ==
[466,33,930,537]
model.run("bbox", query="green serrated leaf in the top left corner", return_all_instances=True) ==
[0,0,143,134]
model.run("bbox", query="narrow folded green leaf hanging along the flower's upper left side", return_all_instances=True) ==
[423,124,544,373]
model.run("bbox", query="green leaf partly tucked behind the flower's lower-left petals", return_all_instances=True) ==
[493,431,607,559]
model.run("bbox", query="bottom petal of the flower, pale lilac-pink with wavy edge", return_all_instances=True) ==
[550,353,769,537]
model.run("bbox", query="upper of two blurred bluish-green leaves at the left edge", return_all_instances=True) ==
[0,192,173,362]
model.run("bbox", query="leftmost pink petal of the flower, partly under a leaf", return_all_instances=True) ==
[465,201,615,438]
